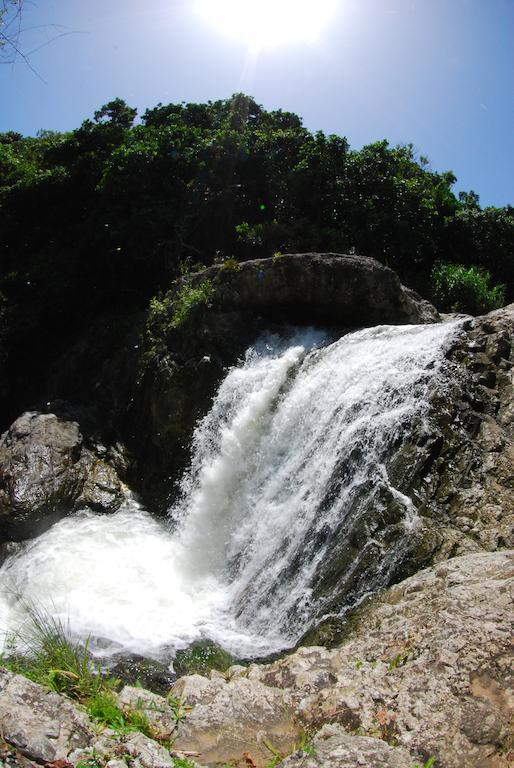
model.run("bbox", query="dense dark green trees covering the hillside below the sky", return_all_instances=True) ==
[0,94,514,424]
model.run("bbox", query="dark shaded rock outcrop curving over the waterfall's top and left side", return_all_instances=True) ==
[131,253,439,506]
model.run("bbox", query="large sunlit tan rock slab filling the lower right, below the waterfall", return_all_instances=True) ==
[174,552,514,768]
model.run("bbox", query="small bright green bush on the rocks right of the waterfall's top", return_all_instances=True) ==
[432,262,506,315]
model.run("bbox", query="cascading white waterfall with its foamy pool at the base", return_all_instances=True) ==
[0,324,455,656]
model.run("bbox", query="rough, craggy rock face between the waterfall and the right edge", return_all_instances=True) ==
[410,304,514,560]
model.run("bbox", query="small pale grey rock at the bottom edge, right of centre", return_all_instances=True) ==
[281,724,412,768]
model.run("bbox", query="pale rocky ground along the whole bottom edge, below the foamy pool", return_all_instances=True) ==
[0,552,514,768]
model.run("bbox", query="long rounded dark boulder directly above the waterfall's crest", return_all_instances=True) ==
[183,253,438,328]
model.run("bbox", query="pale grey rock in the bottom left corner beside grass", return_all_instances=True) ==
[0,667,94,763]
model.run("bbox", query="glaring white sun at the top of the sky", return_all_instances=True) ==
[196,0,338,49]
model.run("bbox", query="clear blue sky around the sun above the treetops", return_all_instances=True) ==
[0,0,514,206]
